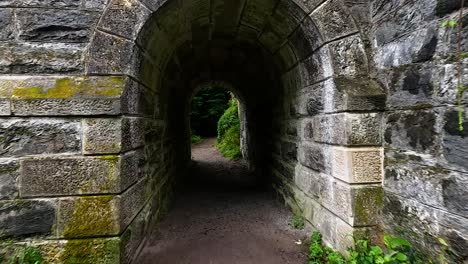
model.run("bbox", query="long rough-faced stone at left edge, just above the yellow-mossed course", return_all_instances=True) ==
[0,42,86,74]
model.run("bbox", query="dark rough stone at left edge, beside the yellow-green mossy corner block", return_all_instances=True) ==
[0,200,57,237]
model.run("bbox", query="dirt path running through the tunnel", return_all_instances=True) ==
[135,139,306,264]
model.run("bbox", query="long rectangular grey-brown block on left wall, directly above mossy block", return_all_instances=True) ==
[20,156,121,197]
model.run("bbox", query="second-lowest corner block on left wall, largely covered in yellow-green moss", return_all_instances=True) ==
[57,195,121,238]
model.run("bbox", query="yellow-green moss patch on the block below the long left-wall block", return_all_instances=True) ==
[63,195,118,238]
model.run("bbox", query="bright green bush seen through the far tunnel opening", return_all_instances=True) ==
[216,99,242,160]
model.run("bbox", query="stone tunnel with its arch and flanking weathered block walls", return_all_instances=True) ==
[0,0,468,263]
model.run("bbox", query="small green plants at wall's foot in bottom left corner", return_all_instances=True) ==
[0,241,44,264]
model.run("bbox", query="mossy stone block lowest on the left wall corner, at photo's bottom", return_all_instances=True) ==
[60,238,120,264]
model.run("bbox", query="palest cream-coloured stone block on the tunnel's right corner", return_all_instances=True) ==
[331,147,383,183]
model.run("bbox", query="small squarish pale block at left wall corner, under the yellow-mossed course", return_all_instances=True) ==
[83,118,123,154]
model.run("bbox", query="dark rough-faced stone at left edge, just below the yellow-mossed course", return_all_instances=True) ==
[0,118,81,157]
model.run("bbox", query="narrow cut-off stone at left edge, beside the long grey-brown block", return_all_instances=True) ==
[0,158,20,200]
